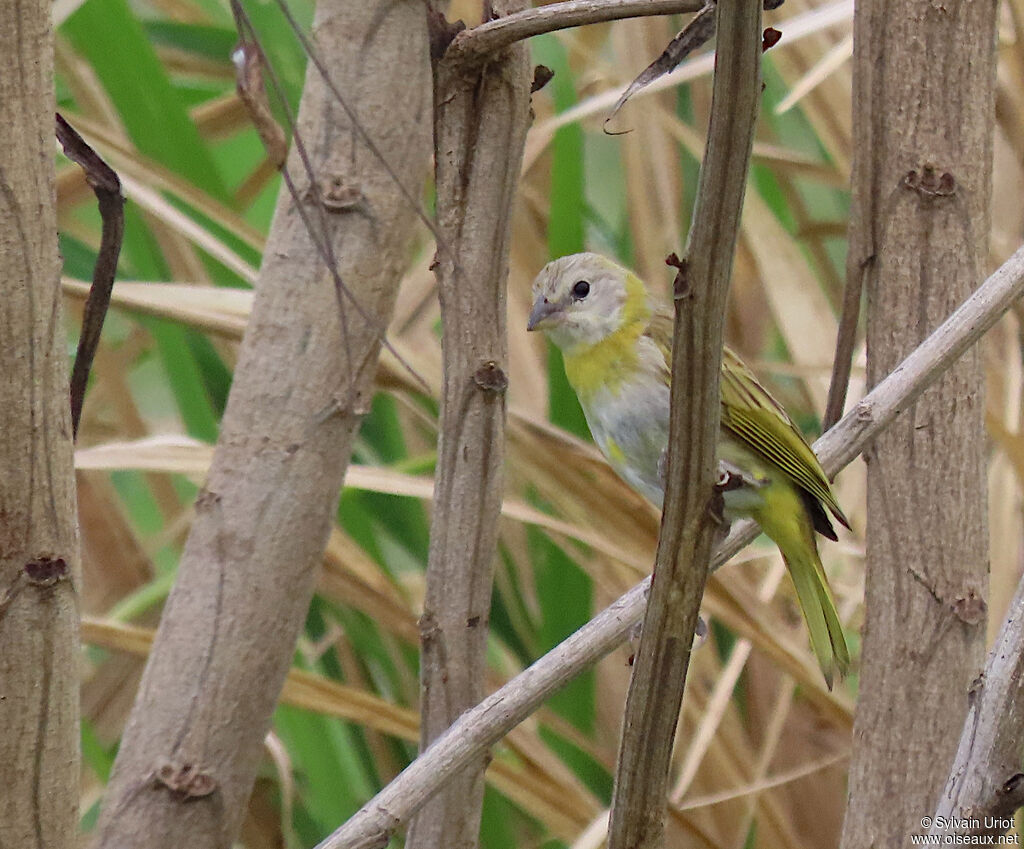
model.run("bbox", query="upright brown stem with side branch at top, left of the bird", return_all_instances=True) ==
[407,6,530,849]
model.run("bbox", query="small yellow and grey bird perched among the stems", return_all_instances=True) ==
[526,253,850,689]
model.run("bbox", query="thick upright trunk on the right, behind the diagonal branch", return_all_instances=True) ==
[842,0,996,849]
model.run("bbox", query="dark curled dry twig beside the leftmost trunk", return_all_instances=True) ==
[56,113,125,436]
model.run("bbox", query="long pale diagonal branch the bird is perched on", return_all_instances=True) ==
[317,239,1024,849]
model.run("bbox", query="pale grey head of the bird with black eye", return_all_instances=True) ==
[526,253,651,351]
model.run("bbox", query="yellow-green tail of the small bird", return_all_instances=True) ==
[755,492,850,689]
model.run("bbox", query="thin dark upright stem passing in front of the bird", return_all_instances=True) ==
[608,0,761,849]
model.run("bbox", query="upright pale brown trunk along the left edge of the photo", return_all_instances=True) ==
[0,0,80,849]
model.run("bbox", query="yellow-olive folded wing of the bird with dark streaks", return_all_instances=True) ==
[644,310,850,527]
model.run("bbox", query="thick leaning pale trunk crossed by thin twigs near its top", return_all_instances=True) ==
[97,0,430,849]
